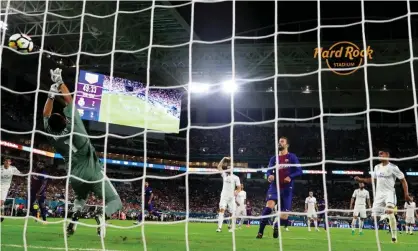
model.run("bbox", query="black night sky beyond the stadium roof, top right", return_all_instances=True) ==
[172,1,418,42]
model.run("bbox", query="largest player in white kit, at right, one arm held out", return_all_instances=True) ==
[354,150,411,243]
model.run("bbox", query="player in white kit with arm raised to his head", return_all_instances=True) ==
[216,157,241,232]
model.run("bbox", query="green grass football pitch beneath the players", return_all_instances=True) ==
[1,219,418,251]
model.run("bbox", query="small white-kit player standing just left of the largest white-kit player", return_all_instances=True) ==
[350,183,371,235]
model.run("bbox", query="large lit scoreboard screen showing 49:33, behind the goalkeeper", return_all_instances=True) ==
[76,70,183,133]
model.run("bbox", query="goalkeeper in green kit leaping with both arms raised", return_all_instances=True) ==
[43,68,122,235]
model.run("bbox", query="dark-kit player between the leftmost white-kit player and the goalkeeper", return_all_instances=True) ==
[30,161,48,222]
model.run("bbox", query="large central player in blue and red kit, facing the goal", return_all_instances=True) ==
[257,137,303,239]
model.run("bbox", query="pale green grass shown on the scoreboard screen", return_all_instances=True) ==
[99,93,180,133]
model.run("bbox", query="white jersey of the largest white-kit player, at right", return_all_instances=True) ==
[372,163,405,196]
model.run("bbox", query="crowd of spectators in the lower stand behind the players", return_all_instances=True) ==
[8,159,417,222]
